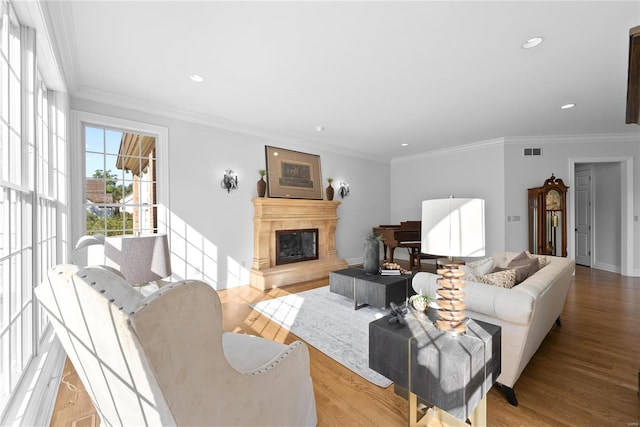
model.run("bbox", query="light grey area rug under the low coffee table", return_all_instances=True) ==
[251,286,392,387]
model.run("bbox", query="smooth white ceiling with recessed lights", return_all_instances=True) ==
[40,1,640,159]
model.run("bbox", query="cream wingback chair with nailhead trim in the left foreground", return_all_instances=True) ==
[36,265,317,426]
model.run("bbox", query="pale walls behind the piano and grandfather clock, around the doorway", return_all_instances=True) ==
[390,133,640,276]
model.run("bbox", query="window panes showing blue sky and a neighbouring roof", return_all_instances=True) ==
[83,126,158,235]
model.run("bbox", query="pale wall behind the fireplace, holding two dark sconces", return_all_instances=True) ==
[72,99,390,289]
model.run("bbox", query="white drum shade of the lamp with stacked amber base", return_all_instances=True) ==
[420,198,485,257]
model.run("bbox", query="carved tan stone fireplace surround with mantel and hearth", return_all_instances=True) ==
[250,197,347,290]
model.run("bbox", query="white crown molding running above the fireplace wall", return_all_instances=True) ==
[72,86,390,164]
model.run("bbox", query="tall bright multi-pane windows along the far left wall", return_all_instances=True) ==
[0,0,66,419]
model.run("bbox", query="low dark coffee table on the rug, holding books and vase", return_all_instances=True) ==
[329,268,415,310]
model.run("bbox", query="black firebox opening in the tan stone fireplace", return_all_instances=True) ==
[276,228,318,265]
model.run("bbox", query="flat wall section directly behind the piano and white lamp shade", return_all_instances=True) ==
[391,140,506,258]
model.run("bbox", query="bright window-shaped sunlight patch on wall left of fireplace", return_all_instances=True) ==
[167,212,249,290]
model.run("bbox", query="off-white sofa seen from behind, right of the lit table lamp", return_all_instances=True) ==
[413,252,575,405]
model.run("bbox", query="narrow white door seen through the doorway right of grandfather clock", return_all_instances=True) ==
[575,166,591,267]
